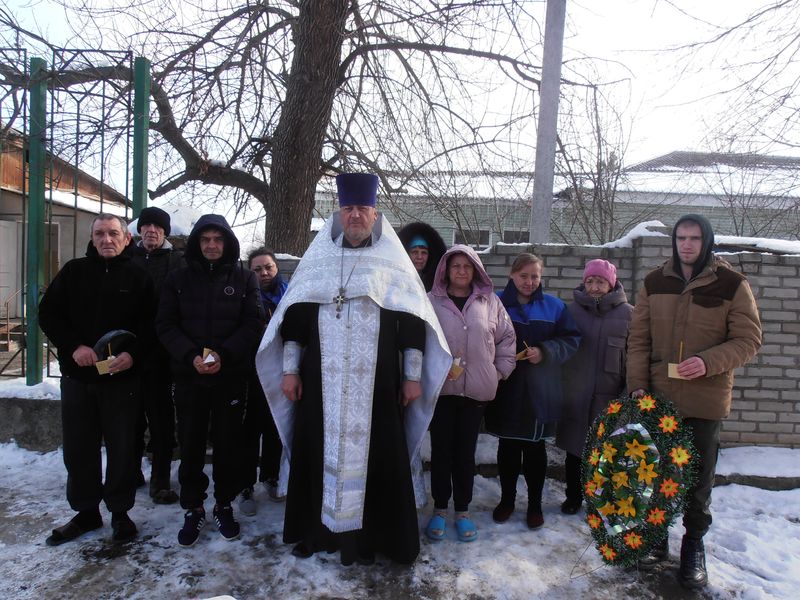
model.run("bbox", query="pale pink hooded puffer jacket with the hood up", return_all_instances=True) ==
[428,244,515,401]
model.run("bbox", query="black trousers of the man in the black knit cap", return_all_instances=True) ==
[136,371,176,489]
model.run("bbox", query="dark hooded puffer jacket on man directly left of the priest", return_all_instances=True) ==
[156,215,263,385]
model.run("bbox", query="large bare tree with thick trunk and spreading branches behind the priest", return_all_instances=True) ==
[0,0,600,254]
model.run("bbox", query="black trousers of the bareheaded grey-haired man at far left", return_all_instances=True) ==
[61,376,141,512]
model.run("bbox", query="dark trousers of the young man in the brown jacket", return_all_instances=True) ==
[683,418,722,539]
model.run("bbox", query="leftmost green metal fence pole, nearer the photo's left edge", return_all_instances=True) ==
[25,58,47,385]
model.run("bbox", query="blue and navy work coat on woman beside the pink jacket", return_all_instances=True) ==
[485,279,581,440]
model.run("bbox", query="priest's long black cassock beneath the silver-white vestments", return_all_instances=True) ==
[280,303,432,564]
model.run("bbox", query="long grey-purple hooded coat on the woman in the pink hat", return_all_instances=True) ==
[556,281,633,456]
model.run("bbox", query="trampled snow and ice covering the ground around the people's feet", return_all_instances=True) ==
[0,444,800,600]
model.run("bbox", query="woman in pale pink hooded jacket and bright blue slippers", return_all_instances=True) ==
[425,244,516,542]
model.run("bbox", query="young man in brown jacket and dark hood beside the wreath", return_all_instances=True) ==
[627,214,761,588]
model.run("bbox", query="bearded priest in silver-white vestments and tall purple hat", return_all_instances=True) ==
[256,173,452,565]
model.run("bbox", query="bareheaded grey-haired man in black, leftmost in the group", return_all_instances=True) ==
[39,214,155,546]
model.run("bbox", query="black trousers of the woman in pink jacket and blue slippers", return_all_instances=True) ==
[431,396,486,511]
